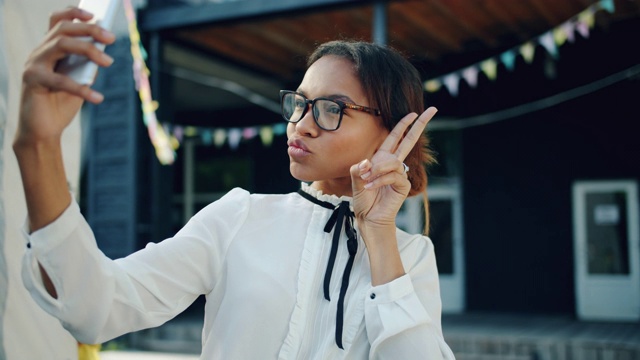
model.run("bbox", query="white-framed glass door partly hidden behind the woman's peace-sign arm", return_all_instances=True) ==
[396,181,465,313]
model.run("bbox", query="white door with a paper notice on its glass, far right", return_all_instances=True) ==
[573,181,640,321]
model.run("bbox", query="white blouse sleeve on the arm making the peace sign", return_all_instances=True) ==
[364,238,454,360]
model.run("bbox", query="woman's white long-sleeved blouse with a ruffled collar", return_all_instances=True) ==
[23,183,454,360]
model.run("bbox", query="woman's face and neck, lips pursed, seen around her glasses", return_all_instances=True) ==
[287,56,389,195]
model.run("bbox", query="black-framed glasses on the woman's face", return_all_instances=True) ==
[280,90,380,131]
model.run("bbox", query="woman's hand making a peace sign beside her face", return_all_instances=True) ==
[350,107,437,242]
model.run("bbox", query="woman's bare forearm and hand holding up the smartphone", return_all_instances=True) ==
[13,8,115,297]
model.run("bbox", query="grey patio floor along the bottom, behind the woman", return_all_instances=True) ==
[105,313,640,360]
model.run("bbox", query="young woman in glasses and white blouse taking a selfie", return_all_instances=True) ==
[14,8,453,359]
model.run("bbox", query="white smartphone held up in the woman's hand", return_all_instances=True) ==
[55,0,121,85]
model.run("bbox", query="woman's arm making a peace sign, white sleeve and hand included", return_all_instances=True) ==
[351,107,453,360]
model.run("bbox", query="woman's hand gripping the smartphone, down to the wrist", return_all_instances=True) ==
[15,8,115,145]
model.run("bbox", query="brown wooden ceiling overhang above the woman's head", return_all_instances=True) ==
[139,0,640,82]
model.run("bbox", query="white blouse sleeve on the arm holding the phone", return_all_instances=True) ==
[22,189,249,344]
